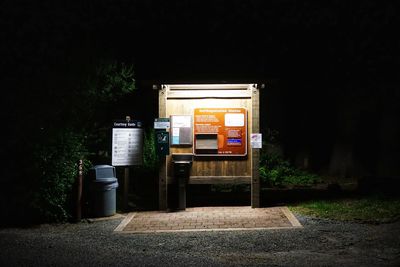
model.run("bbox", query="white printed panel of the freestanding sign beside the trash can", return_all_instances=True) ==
[111,128,143,166]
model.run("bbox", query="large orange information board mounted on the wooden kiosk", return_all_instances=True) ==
[193,108,247,156]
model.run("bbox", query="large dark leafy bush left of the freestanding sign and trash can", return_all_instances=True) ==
[10,62,136,222]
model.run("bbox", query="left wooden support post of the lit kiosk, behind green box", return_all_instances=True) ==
[158,85,167,210]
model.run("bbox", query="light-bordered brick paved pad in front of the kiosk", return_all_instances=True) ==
[115,207,301,233]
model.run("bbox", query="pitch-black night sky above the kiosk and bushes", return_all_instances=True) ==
[0,0,400,178]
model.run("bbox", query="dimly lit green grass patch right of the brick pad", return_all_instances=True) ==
[289,195,400,223]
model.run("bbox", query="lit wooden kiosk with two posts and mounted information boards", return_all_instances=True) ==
[159,84,259,209]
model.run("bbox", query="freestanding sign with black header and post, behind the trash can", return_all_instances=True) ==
[111,116,143,211]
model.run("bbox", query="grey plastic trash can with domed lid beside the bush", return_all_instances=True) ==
[90,165,118,217]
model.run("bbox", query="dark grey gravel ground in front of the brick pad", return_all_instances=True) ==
[0,214,400,266]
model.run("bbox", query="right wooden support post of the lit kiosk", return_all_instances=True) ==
[251,85,260,208]
